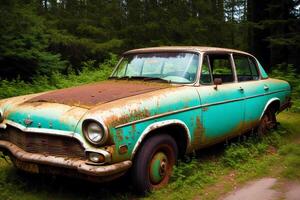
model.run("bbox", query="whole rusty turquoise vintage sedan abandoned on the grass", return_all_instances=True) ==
[0,46,291,192]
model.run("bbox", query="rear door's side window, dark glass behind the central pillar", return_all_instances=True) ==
[233,55,259,82]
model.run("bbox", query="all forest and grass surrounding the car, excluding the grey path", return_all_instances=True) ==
[0,0,300,200]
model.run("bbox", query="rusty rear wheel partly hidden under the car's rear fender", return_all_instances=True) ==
[257,108,277,135]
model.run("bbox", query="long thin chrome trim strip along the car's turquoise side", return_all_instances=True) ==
[115,90,288,129]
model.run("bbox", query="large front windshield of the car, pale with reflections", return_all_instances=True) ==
[111,52,199,84]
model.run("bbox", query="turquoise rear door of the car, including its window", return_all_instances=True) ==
[233,54,269,131]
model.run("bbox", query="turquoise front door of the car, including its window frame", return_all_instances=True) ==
[197,53,244,146]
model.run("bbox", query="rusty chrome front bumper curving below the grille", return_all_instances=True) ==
[0,140,132,177]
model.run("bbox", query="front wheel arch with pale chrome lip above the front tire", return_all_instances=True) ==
[131,119,191,160]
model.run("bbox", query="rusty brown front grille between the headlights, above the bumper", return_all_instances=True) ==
[3,127,85,159]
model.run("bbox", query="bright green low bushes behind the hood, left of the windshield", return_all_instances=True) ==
[0,54,117,99]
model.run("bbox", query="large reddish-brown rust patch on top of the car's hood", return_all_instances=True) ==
[27,80,171,108]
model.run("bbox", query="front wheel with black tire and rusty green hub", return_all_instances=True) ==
[131,134,178,194]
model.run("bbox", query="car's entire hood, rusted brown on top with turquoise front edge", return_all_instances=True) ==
[0,80,172,132]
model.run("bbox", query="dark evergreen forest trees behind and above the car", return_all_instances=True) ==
[0,0,300,80]
